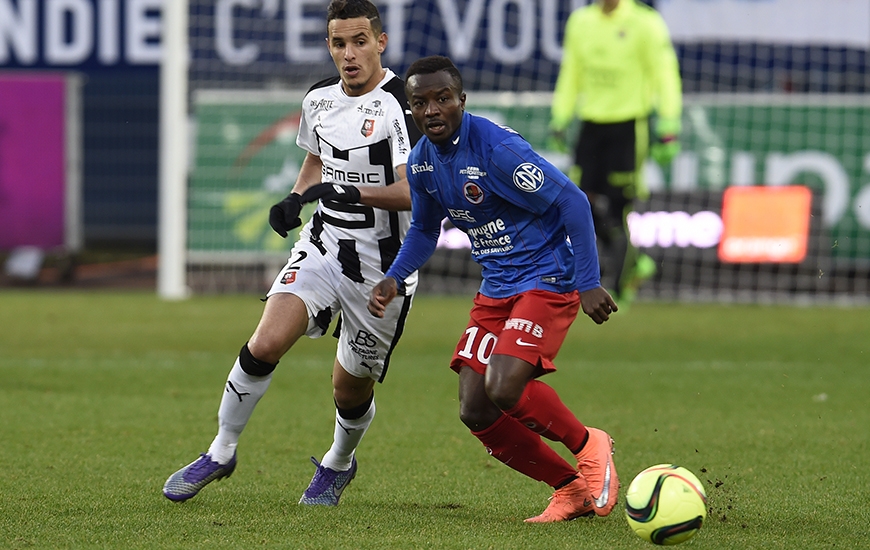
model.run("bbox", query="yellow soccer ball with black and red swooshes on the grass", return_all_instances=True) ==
[625,464,707,545]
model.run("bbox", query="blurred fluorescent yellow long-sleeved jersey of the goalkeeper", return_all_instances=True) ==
[550,0,683,133]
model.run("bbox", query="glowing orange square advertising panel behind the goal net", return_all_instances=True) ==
[719,185,812,263]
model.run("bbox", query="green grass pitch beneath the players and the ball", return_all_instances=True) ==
[0,290,870,550]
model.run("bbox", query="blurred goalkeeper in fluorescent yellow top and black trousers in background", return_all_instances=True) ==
[550,0,682,305]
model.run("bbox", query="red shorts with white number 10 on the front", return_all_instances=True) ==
[450,290,580,374]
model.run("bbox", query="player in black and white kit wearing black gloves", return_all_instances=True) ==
[163,0,420,506]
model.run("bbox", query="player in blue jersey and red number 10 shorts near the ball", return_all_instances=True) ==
[368,56,619,523]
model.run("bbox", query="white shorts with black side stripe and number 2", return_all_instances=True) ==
[266,240,413,382]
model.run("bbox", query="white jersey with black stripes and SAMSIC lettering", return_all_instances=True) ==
[296,69,420,292]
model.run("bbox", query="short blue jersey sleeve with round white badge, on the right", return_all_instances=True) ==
[489,135,573,215]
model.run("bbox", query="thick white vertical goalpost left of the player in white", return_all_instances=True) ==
[157,0,189,300]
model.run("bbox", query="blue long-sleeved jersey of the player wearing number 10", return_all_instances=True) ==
[387,112,600,298]
